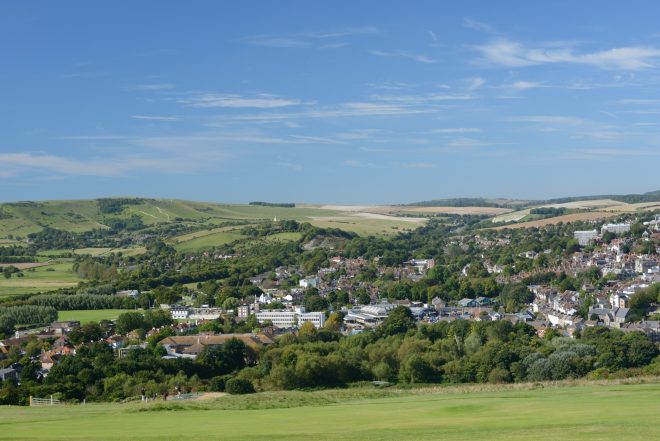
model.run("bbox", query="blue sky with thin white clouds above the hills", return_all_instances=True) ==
[0,0,660,203]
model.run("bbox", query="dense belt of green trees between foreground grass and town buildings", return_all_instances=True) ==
[0,307,660,403]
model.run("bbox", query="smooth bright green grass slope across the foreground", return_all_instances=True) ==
[0,383,660,441]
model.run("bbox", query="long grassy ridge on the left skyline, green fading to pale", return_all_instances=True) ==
[0,199,430,241]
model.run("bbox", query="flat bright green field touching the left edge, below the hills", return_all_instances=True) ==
[0,262,81,297]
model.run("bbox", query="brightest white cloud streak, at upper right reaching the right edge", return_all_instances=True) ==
[476,39,660,71]
